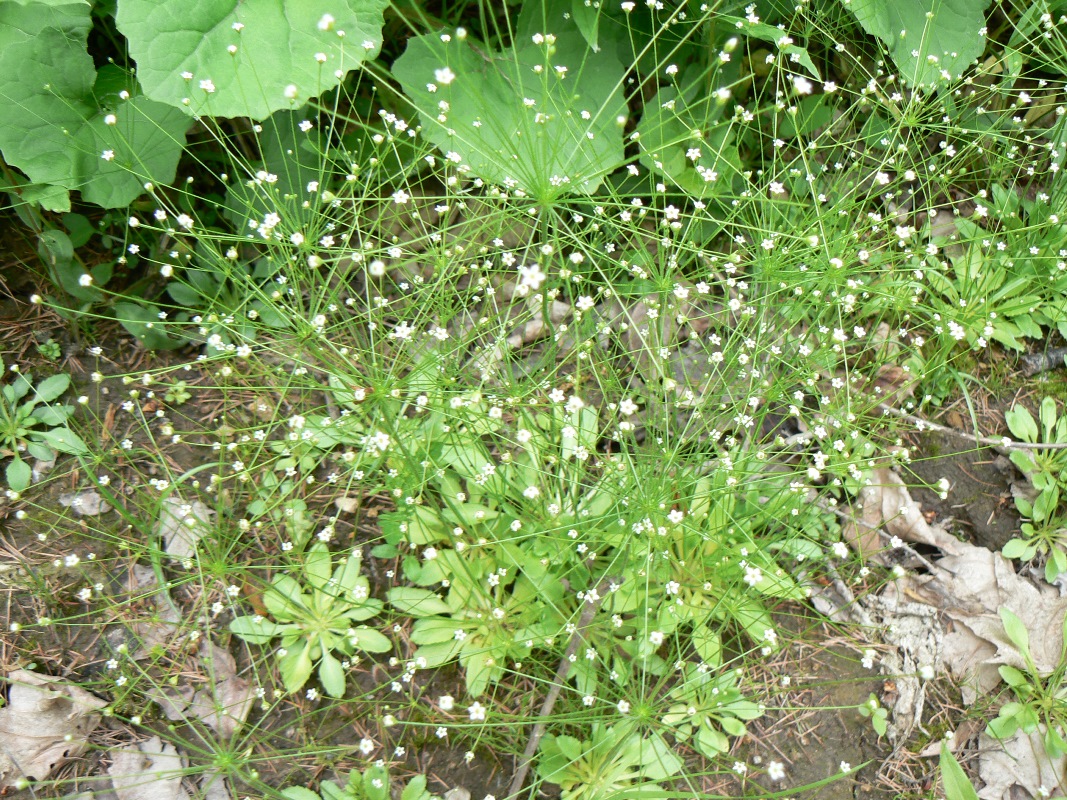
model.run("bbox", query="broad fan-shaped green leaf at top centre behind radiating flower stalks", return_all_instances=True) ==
[393,3,626,203]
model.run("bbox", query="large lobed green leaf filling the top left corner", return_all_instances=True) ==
[0,4,189,210]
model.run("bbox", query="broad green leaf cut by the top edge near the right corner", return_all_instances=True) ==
[842,0,989,86]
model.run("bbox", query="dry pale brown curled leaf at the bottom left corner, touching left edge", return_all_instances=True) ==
[0,670,107,788]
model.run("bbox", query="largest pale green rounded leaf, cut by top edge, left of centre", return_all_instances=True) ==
[115,0,387,119]
